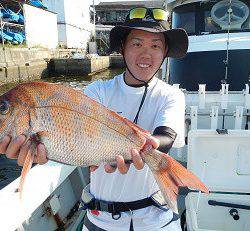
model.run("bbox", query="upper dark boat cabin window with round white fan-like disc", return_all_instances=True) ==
[172,0,250,35]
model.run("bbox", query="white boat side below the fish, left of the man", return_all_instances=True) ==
[0,161,89,231]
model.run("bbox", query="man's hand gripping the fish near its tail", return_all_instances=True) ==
[90,136,159,174]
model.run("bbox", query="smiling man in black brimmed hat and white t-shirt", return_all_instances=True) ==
[0,8,188,231]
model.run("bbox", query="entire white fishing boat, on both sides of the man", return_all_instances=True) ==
[0,0,250,231]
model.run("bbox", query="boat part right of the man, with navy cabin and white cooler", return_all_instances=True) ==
[167,0,250,231]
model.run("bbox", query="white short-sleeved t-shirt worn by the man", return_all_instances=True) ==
[84,74,185,231]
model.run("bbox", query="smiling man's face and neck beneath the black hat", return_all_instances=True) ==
[124,29,166,84]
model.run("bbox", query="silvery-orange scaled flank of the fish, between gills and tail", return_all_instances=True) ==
[8,84,144,166]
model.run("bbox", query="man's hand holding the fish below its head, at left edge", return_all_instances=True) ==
[0,135,48,166]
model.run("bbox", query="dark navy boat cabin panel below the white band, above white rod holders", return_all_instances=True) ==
[168,49,250,91]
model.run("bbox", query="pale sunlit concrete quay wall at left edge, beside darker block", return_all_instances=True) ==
[0,47,79,84]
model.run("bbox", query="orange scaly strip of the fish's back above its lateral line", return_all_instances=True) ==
[26,84,148,146]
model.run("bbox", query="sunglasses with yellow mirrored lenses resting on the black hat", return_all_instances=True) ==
[128,7,169,21]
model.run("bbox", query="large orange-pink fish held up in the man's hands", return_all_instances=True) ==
[0,82,209,210]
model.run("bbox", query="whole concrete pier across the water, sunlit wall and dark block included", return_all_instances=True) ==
[0,47,125,85]
